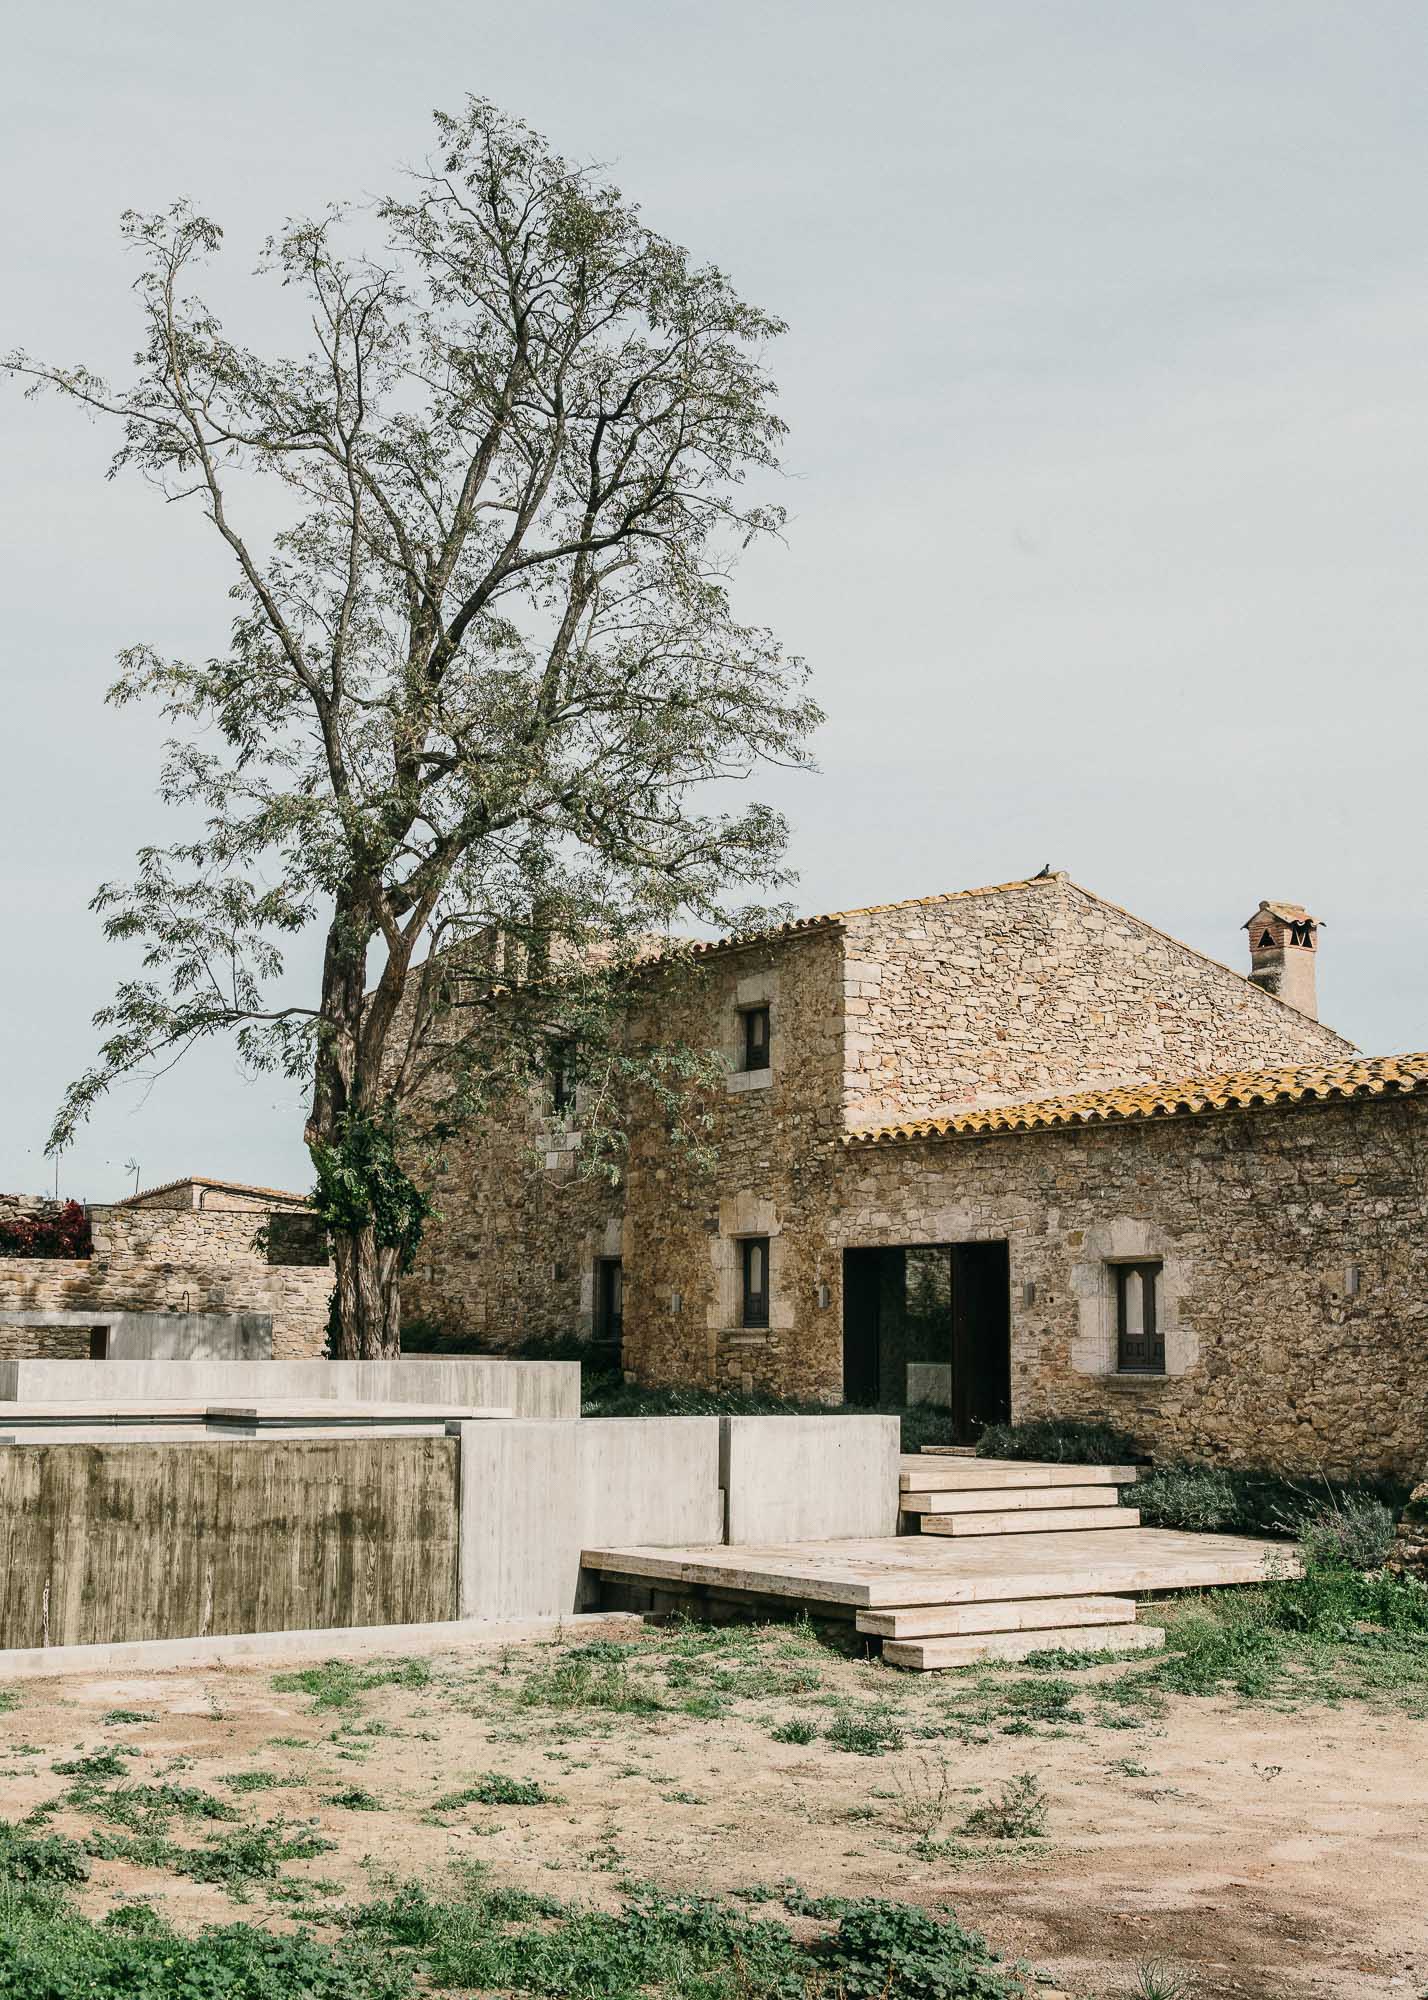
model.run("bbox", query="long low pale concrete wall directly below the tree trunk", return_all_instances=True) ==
[0,1354,580,1418]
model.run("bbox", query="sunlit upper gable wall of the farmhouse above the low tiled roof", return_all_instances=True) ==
[842,876,1354,1126]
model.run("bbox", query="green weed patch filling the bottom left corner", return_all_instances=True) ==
[0,1900,414,2000]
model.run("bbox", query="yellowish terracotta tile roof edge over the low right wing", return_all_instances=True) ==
[844,1052,1428,1146]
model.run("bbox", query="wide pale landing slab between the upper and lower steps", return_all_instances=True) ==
[582,1528,1298,1612]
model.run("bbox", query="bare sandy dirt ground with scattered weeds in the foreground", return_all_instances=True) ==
[0,1622,1428,2000]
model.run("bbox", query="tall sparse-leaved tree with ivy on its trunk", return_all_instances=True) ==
[8,100,818,1356]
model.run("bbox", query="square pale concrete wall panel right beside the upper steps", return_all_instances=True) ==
[718,1416,898,1542]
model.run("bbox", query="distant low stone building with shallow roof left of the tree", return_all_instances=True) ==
[0,1176,332,1360]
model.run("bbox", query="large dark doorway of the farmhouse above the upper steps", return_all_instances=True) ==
[842,1242,1012,1444]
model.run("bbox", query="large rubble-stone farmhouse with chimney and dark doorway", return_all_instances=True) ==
[404,872,1428,1474]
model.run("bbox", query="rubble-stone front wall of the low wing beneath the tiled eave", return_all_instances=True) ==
[828,1096,1428,1476]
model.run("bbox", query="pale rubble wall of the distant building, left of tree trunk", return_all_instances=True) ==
[0,1206,332,1360]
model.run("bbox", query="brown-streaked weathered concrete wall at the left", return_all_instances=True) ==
[0,1438,458,1648]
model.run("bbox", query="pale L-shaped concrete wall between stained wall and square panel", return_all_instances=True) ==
[460,1416,724,1618]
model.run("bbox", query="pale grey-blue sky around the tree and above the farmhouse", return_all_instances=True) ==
[0,0,1428,1200]
